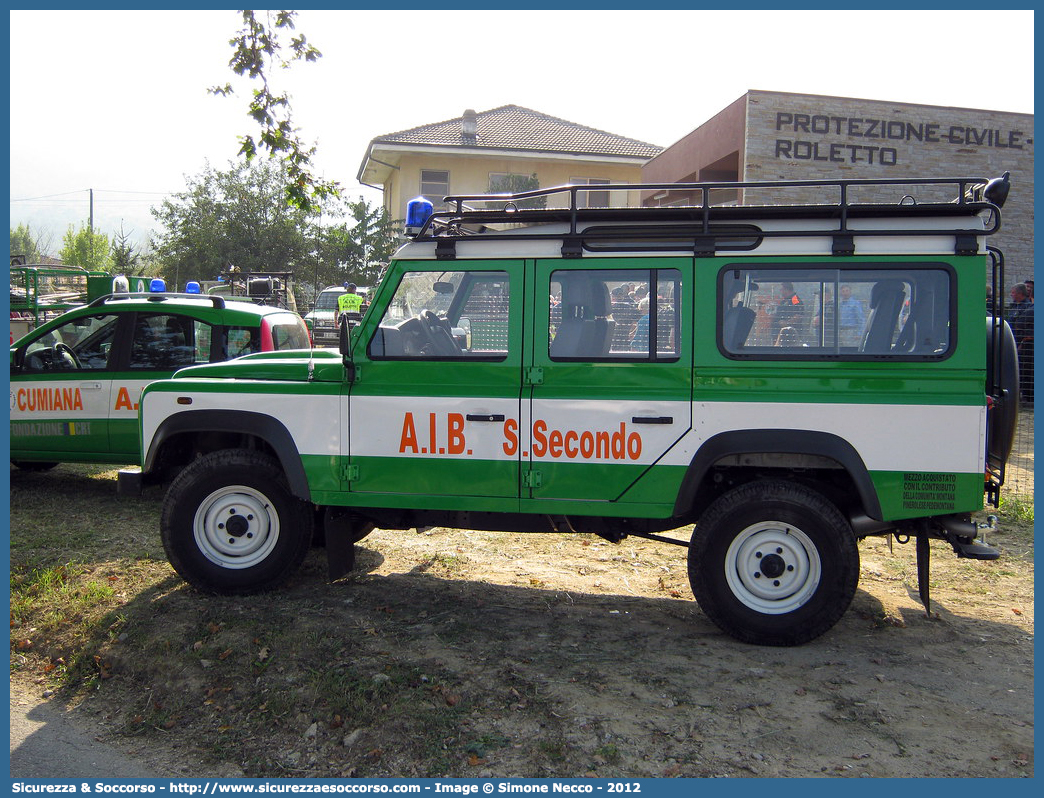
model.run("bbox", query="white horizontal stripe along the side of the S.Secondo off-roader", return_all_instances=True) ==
[144,393,986,473]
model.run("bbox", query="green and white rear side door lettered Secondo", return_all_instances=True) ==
[521,258,692,501]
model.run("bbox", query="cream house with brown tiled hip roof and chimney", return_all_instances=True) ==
[358,105,663,218]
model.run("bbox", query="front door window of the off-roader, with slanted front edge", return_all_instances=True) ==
[367,272,511,360]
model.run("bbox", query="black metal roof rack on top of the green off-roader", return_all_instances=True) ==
[410,172,1010,259]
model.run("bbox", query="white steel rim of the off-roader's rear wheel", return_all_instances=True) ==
[725,521,823,615]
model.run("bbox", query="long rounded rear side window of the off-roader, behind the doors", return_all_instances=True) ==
[718,265,951,358]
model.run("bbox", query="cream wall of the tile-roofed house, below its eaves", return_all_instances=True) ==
[384,152,642,219]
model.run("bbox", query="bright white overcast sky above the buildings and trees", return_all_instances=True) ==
[9,9,1034,252]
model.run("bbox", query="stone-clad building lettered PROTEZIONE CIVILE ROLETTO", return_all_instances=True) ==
[642,91,1034,284]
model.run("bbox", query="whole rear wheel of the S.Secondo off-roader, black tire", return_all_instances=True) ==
[689,479,859,646]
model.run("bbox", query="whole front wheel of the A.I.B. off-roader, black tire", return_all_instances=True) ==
[160,449,314,594]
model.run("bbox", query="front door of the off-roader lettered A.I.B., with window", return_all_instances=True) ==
[342,260,524,499]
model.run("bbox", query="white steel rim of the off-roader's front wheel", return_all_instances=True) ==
[192,485,279,569]
